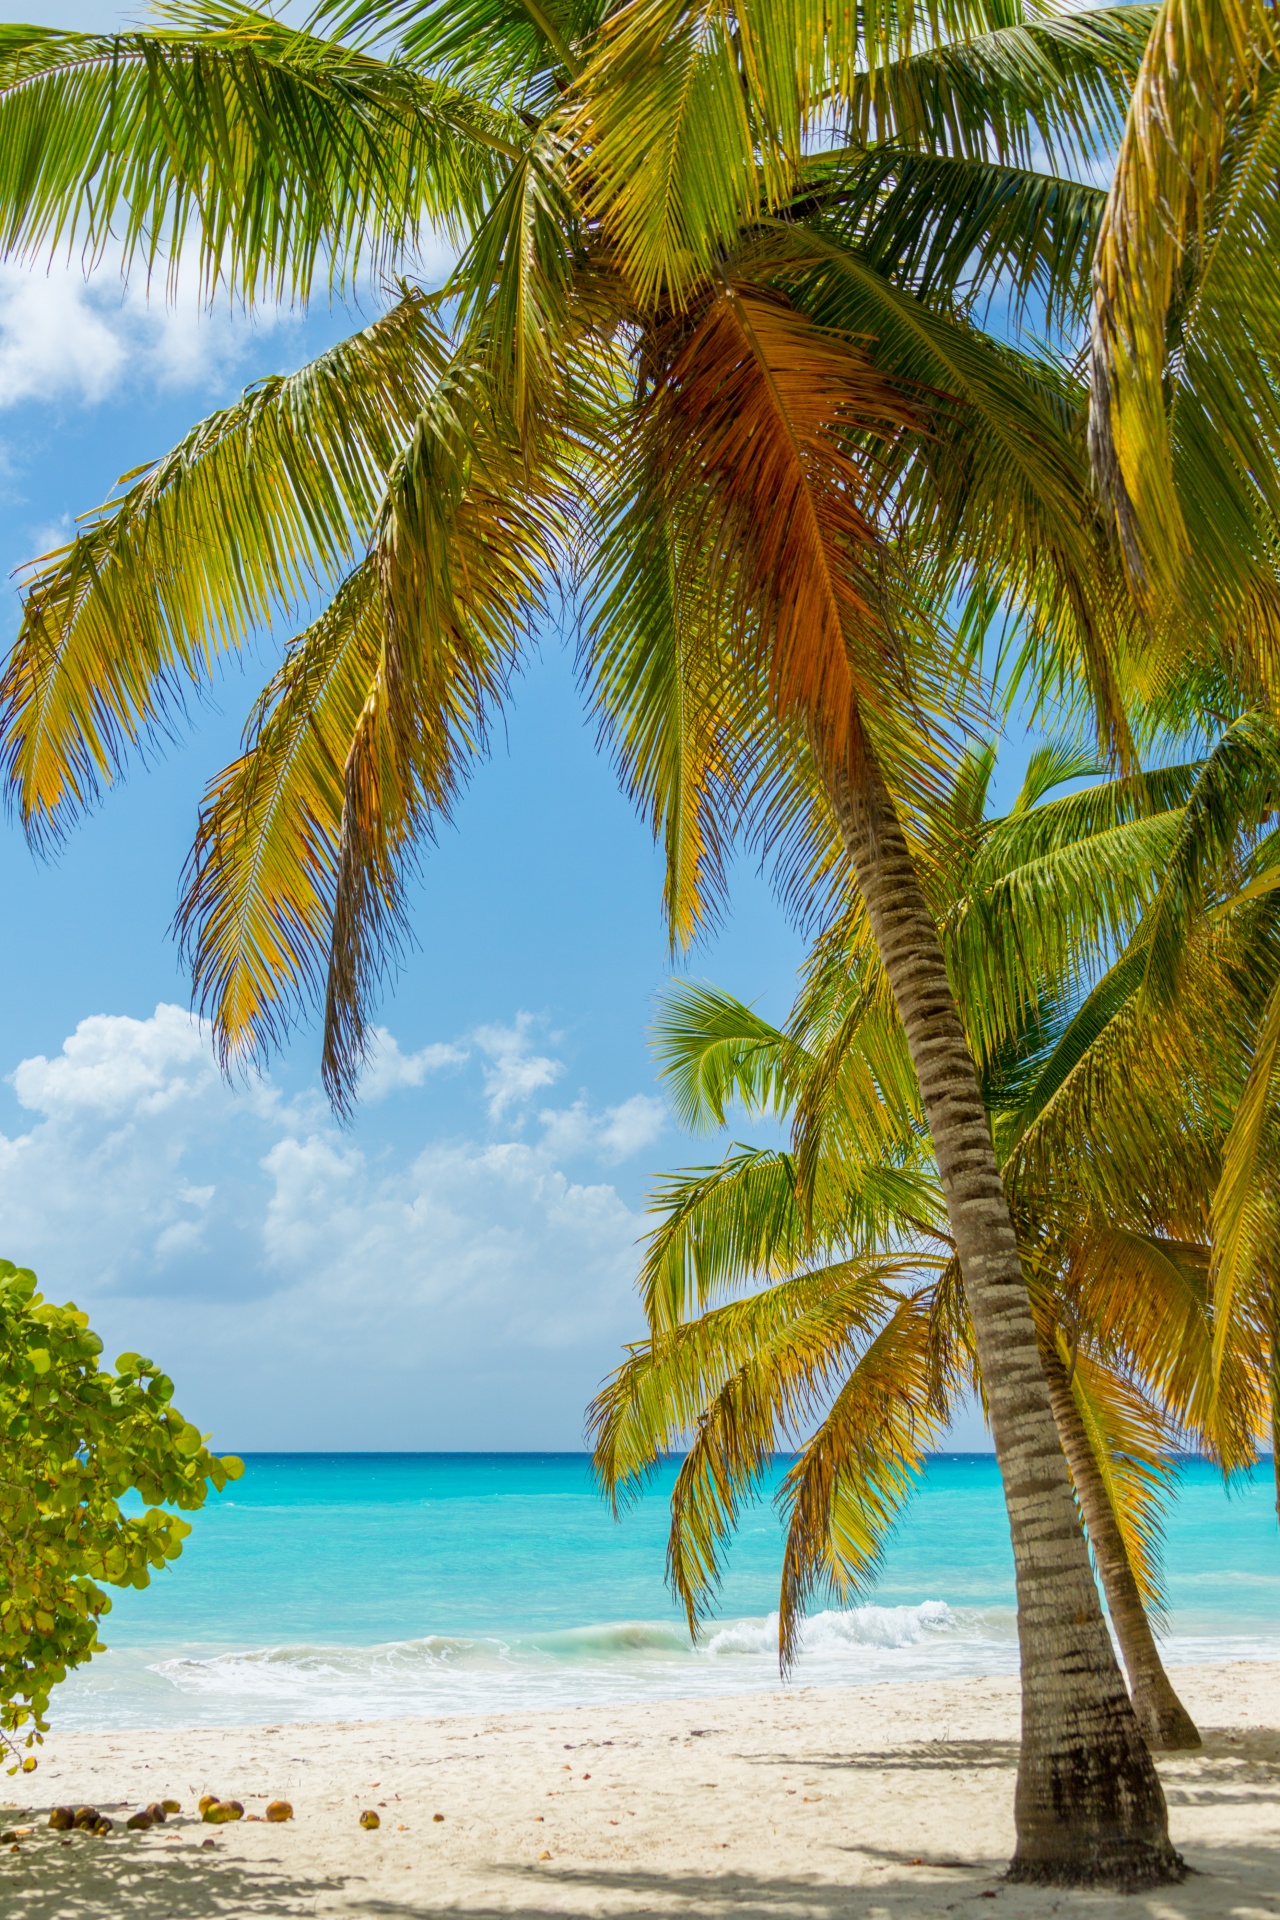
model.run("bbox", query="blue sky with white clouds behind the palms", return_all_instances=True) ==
[0,6,986,1450]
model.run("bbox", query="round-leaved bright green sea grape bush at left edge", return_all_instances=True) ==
[0,1260,244,1772]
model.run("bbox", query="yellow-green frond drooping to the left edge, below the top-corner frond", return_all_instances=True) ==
[0,294,445,839]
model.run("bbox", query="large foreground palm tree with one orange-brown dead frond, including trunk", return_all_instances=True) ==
[0,0,1180,1885]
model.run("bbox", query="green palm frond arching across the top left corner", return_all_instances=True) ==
[0,0,524,301]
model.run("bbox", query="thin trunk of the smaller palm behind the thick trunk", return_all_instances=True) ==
[1042,1350,1201,1753]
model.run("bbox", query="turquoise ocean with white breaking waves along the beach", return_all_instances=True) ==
[54,1453,1280,1728]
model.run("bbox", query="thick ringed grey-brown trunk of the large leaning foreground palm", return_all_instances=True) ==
[825,747,1184,1889]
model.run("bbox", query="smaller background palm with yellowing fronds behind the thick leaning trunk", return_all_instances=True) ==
[593,735,1280,1749]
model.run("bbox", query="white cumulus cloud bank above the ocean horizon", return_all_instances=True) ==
[0,1006,662,1446]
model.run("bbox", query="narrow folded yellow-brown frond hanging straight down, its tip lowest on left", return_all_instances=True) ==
[322,359,568,1110]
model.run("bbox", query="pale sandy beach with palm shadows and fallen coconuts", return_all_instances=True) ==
[0,1661,1280,1920]
